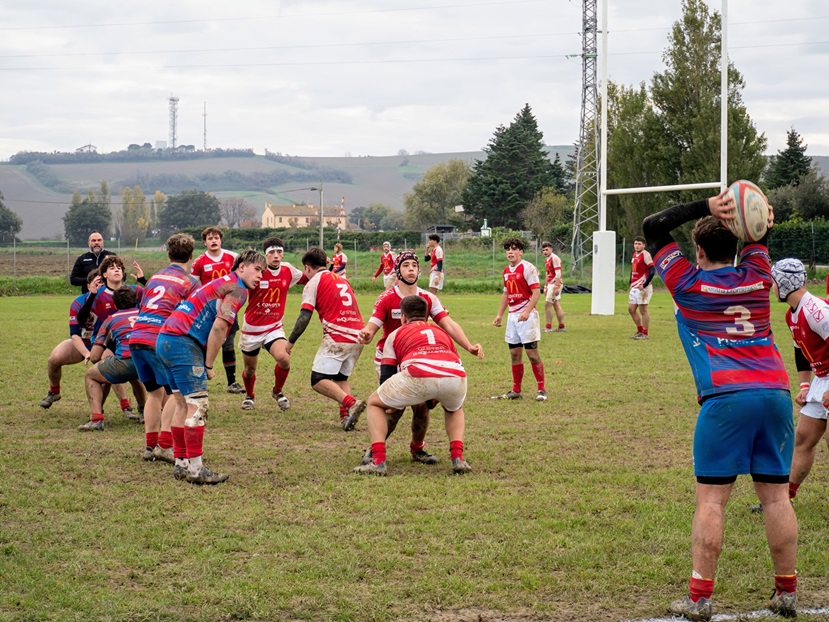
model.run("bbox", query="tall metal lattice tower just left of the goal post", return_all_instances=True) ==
[570,0,599,273]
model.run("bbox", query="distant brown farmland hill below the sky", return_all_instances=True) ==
[0,145,829,239]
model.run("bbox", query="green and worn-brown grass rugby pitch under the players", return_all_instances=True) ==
[0,292,829,622]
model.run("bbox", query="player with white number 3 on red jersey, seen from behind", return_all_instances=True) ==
[286,247,366,432]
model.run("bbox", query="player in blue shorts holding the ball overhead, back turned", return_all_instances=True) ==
[643,193,797,620]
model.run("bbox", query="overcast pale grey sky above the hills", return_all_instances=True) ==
[0,0,829,159]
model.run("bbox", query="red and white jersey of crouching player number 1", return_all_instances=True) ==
[381,322,466,378]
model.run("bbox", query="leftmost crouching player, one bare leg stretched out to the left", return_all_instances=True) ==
[40,268,129,409]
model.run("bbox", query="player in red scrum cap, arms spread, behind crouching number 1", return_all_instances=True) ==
[360,251,484,464]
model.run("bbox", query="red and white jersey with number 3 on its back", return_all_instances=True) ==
[302,270,363,343]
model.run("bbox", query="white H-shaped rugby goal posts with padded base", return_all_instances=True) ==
[590,0,728,315]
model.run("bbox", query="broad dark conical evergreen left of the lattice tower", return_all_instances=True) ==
[462,104,556,229]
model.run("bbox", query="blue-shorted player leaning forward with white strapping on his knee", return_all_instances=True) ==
[155,249,267,484]
